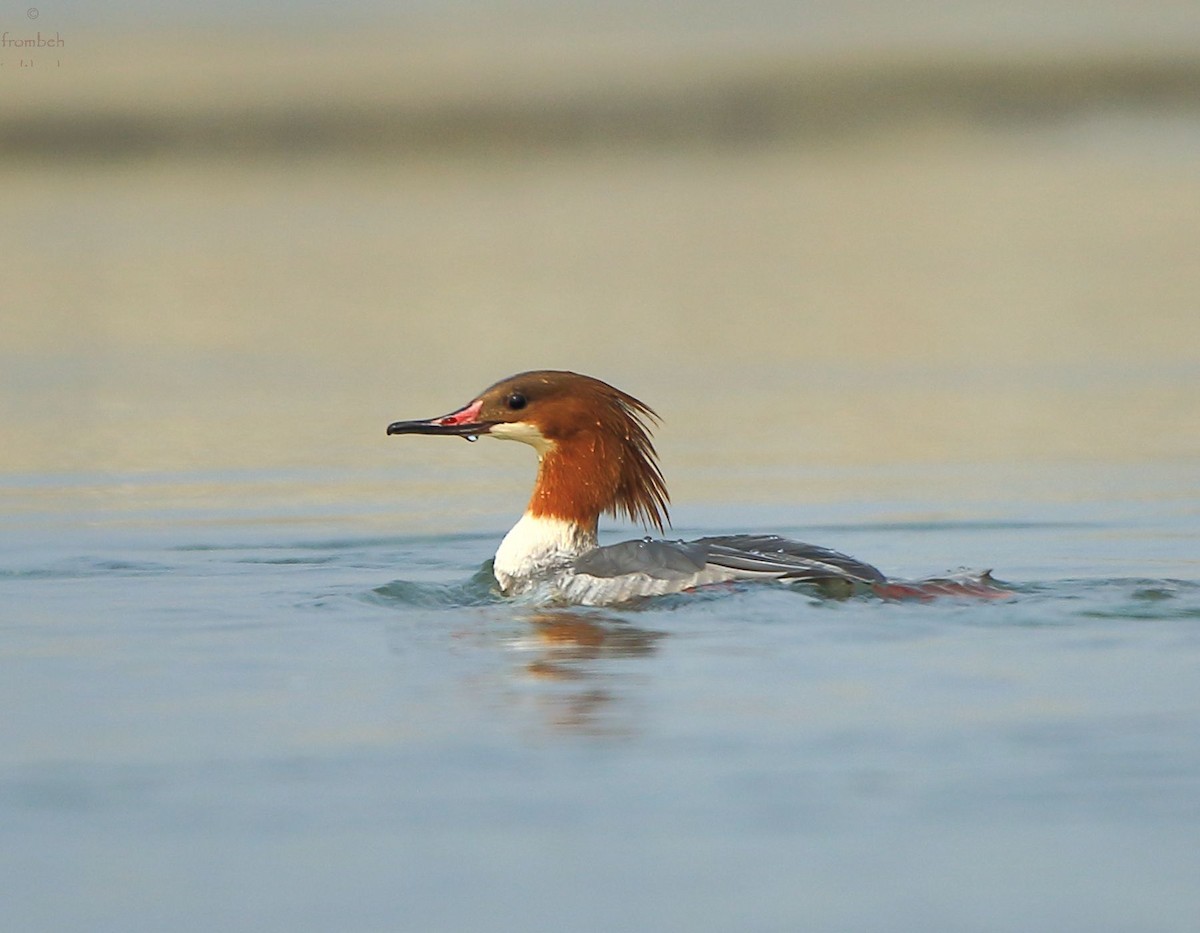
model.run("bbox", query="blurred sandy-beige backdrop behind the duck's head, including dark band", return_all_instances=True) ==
[0,17,1200,520]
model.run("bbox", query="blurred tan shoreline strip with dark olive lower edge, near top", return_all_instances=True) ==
[0,34,1200,161]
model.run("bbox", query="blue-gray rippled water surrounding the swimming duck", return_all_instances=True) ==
[0,460,1200,933]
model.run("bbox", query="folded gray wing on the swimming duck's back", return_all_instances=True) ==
[574,535,884,583]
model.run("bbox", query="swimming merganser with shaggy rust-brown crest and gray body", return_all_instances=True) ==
[388,369,1007,606]
